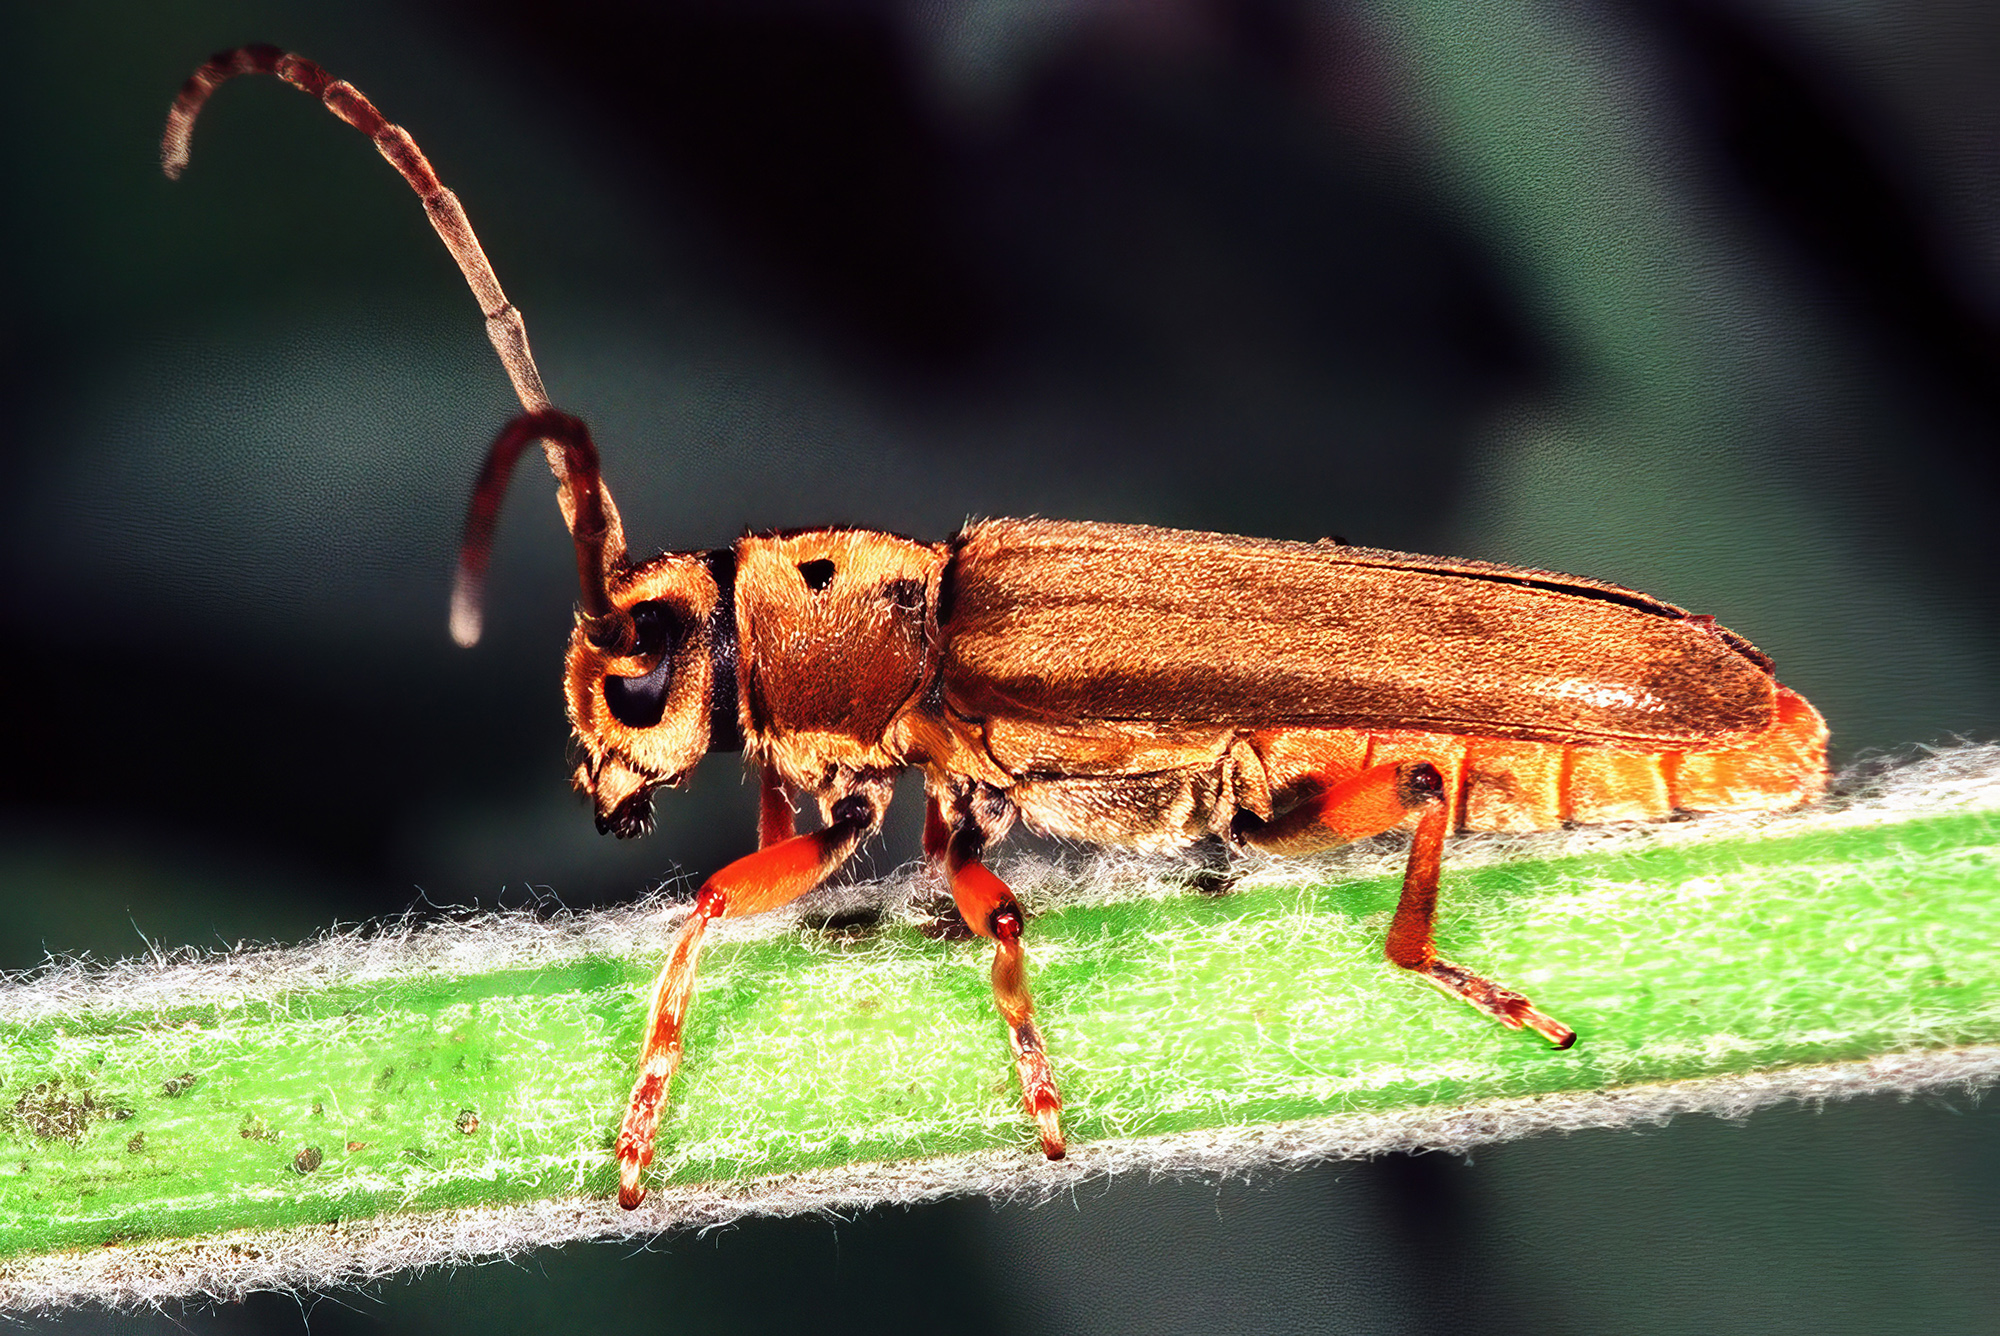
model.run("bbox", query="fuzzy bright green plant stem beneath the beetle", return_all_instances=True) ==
[0,760,2000,1304]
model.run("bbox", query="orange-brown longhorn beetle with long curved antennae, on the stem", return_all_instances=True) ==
[172,46,1826,1208]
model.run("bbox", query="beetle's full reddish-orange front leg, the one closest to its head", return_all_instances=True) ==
[618,808,870,1210]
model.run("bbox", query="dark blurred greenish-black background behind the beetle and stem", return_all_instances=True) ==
[0,0,2000,1336]
